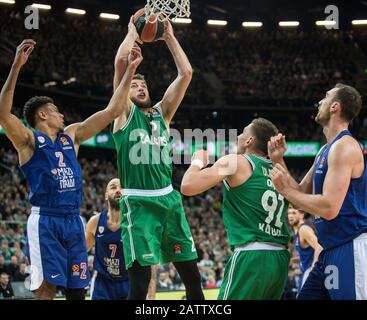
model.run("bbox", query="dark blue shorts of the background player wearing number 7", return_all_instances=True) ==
[91,272,129,300]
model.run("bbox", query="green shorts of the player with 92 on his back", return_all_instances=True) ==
[218,245,290,300]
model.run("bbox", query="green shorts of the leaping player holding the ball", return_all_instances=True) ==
[120,190,197,268]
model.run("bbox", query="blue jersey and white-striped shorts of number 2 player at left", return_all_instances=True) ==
[20,131,89,291]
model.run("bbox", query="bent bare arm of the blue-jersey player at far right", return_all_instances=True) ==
[270,140,361,220]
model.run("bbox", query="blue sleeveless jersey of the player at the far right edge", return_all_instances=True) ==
[313,130,367,250]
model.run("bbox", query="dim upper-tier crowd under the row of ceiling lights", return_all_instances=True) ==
[0,9,367,105]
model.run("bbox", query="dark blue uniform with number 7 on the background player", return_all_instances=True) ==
[91,211,129,300]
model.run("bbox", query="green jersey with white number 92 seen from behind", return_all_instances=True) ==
[223,154,290,246]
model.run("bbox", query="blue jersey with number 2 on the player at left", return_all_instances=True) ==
[20,131,83,215]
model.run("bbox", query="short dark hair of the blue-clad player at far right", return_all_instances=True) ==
[335,83,362,122]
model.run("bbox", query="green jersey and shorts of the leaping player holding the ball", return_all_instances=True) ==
[113,105,197,268]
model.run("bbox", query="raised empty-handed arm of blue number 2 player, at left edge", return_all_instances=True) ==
[0,39,36,154]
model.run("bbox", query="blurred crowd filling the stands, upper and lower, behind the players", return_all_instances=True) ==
[0,8,367,298]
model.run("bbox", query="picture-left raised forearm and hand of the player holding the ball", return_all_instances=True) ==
[113,16,141,91]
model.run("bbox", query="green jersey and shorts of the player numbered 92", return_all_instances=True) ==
[218,154,290,300]
